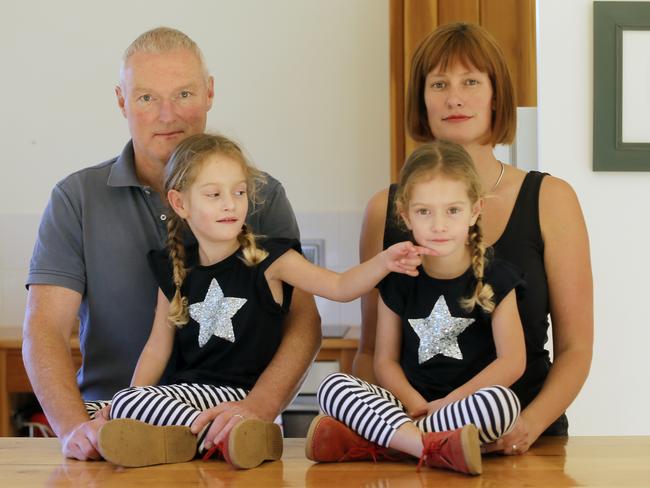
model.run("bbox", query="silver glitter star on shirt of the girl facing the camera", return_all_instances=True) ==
[408,295,474,364]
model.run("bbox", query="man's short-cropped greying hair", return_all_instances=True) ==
[120,27,210,85]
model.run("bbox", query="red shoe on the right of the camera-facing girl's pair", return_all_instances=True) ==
[418,424,482,474]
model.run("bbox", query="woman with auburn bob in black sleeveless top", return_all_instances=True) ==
[354,23,593,454]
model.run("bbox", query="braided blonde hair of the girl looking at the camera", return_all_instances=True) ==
[395,140,494,313]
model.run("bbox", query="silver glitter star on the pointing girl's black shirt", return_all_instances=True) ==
[189,278,246,347]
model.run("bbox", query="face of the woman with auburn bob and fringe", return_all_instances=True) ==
[424,62,494,146]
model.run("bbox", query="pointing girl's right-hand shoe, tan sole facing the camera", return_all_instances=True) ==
[203,419,283,469]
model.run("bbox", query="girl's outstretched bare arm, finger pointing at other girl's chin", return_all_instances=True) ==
[265,241,435,302]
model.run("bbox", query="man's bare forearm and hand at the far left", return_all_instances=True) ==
[23,285,105,461]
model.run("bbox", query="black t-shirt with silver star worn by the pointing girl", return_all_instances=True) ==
[149,238,301,390]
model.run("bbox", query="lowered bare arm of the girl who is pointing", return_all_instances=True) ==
[131,289,175,386]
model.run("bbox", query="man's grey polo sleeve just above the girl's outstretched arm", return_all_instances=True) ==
[246,174,300,240]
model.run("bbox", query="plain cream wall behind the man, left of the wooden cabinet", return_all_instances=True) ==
[0,0,390,325]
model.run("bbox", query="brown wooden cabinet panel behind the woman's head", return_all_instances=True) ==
[390,0,537,181]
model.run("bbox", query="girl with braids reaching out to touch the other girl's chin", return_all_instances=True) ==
[99,134,435,468]
